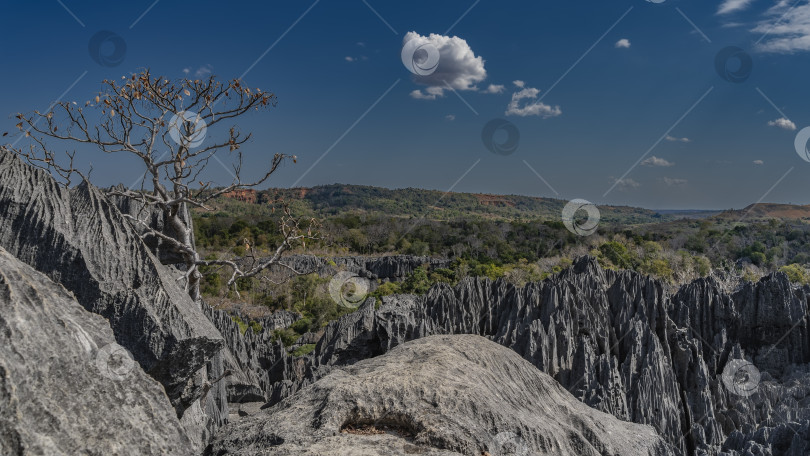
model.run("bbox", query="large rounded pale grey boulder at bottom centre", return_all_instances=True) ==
[206,336,673,456]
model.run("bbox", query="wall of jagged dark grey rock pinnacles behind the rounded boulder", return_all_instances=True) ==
[213,258,810,455]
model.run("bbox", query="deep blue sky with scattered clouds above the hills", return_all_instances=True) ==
[0,0,810,208]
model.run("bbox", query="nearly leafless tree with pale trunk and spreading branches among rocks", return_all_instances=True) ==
[9,70,318,300]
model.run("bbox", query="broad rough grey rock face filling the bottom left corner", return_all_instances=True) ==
[0,248,193,456]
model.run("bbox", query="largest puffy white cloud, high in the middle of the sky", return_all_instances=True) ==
[403,32,487,99]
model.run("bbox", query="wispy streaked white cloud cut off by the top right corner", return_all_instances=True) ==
[751,0,810,54]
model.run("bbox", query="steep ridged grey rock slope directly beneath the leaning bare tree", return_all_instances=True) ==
[0,152,224,416]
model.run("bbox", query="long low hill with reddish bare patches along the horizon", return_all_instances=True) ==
[205,184,664,225]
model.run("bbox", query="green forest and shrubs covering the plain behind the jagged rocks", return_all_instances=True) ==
[194,185,810,346]
